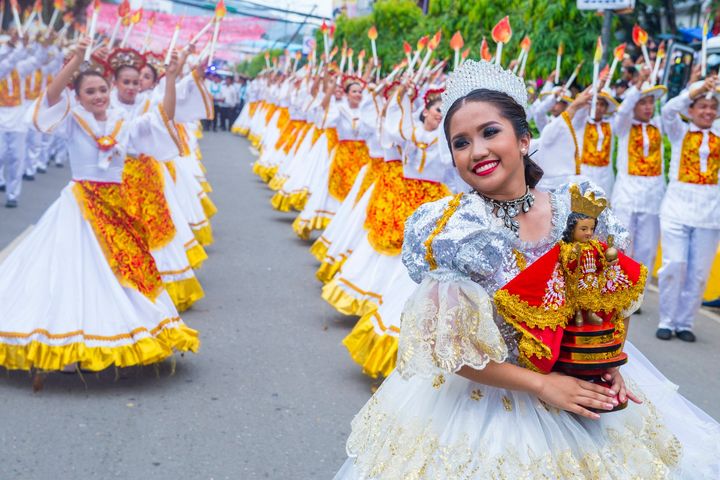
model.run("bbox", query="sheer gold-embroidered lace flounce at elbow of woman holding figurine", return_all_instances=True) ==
[397,272,508,378]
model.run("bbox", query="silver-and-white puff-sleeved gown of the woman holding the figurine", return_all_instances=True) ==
[335,185,720,480]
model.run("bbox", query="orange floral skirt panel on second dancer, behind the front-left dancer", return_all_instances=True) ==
[122,155,175,250]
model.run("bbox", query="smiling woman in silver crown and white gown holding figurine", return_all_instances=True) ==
[336,61,720,480]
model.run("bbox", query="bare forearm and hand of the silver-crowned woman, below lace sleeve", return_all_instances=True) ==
[458,362,617,419]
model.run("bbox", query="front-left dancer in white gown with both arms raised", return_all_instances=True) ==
[0,39,199,380]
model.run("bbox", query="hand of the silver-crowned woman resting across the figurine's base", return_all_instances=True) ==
[537,372,622,420]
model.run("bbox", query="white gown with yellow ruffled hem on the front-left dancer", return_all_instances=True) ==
[0,93,199,370]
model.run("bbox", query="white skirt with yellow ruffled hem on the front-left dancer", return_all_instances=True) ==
[0,183,199,370]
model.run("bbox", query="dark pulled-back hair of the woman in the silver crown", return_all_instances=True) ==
[443,88,543,188]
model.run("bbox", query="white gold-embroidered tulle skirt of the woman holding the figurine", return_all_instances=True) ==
[335,342,720,480]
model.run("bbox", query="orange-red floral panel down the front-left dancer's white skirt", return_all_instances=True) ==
[73,181,164,300]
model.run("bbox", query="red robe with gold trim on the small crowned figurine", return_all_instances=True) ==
[495,240,647,373]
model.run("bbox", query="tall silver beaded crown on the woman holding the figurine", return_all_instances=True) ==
[442,60,527,112]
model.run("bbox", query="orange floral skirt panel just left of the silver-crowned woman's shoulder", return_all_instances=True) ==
[365,161,450,255]
